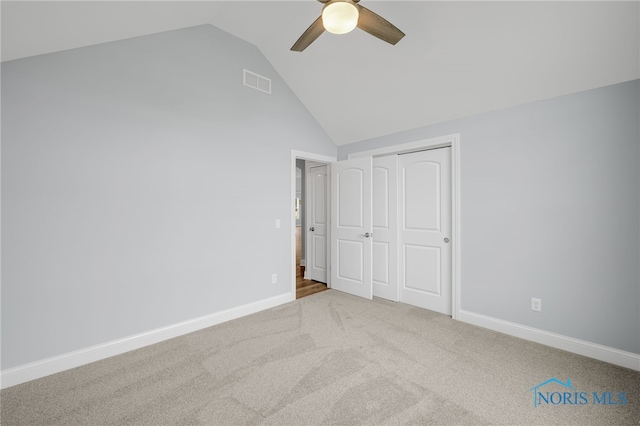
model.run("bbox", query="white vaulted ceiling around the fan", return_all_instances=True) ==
[1,0,640,145]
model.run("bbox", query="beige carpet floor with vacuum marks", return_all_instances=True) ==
[0,290,640,426]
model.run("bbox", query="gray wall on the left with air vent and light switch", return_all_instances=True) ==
[2,25,337,369]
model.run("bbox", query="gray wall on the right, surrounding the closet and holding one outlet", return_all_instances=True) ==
[339,80,640,353]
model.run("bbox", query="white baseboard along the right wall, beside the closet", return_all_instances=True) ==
[458,310,640,371]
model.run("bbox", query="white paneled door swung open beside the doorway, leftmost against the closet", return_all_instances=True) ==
[331,157,373,299]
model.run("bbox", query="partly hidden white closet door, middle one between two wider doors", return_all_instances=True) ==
[372,155,398,302]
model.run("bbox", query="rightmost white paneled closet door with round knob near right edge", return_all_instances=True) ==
[398,148,451,315]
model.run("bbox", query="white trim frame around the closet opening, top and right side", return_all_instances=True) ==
[347,133,461,320]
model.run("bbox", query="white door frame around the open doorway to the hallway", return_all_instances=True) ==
[289,149,338,300]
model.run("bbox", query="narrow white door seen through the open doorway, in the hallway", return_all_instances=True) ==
[305,165,327,283]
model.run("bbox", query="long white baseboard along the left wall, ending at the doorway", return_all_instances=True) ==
[0,293,295,389]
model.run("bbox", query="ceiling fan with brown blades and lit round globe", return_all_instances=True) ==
[291,0,404,52]
